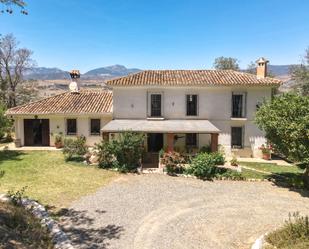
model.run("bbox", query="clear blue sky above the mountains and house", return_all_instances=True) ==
[0,0,309,72]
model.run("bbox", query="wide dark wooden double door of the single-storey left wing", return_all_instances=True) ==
[24,119,49,146]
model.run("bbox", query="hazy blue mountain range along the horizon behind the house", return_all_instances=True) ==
[24,65,292,80]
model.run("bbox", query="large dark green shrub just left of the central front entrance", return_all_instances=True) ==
[96,132,145,172]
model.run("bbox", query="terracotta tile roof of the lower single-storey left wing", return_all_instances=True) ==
[6,89,113,115]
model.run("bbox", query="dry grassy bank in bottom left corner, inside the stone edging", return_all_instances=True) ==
[0,202,54,249]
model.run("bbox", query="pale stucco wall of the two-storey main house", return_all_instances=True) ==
[113,87,271,157]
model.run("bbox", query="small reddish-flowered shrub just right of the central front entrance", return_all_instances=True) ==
[161,151,185,174]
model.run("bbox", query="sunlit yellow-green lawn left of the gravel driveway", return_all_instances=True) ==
[0,151,117,209]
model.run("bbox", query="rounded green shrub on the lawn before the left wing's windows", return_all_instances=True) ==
[62,136,88,161]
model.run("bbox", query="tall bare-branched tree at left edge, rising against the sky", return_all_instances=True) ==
[0,34,34,108]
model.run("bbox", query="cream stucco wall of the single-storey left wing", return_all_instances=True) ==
[14,114,112,146]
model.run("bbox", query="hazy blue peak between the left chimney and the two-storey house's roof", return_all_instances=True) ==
[82,65,141,79]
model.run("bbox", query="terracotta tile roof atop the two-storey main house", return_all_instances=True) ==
[107,70,282,86]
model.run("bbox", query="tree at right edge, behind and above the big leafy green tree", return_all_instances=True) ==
[290,48,309,96]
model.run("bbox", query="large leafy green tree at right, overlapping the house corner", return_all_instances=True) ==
[255,93,309,188]
